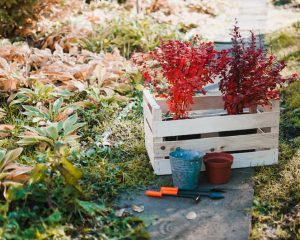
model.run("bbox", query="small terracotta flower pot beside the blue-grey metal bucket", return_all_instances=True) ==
[203,153,233,184]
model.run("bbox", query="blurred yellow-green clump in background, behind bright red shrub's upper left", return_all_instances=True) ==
[80,14,181,58]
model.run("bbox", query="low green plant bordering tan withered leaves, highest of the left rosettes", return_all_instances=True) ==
[10,82,71,105]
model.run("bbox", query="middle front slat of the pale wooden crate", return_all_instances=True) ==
[154,133,278,158]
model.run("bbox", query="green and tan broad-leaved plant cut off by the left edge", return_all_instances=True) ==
[0,148,32,199]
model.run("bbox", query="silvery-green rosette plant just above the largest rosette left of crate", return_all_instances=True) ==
[23,98,79,125]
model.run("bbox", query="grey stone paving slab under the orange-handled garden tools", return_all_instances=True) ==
[118,168,254,240]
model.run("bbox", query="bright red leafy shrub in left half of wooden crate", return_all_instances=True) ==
[135,36,226,119]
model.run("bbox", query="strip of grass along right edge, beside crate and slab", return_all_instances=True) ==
[251,23,300,240]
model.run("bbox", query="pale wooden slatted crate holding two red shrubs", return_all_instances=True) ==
[143,90,280,175]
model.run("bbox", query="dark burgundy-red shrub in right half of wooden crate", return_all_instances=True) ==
[219,26,297,114]
